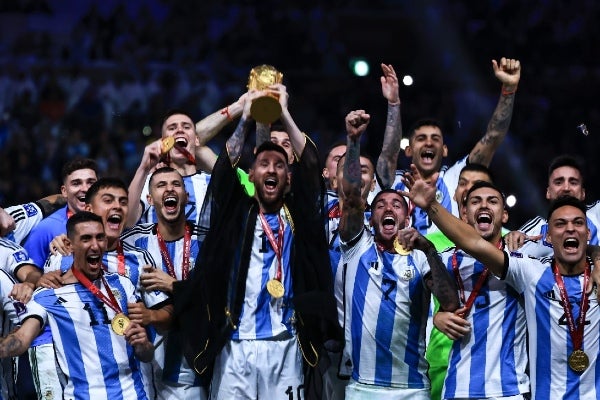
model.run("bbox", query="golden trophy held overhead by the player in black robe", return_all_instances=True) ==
[248,64,283,124]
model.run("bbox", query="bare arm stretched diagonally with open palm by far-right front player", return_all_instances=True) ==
[402,165,505,276]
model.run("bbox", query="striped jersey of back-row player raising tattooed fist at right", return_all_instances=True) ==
[392,155,469,236]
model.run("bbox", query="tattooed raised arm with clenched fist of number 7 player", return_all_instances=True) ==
[338,110,371,242]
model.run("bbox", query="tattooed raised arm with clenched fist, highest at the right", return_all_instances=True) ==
[469,57,521,167]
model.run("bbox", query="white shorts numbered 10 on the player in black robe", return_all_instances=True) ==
[210,337,304,400]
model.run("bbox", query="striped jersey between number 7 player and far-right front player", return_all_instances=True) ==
[441,249,529,399]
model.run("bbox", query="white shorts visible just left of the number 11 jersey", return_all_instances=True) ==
[29,343,66,399]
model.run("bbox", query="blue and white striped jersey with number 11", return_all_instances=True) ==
[21,273,147,400]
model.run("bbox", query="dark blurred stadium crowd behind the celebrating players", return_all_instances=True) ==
[0,0,600,228]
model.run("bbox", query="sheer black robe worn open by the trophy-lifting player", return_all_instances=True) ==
[173,138,343,397]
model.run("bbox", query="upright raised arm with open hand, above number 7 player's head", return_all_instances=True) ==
[377,64,402,189]
